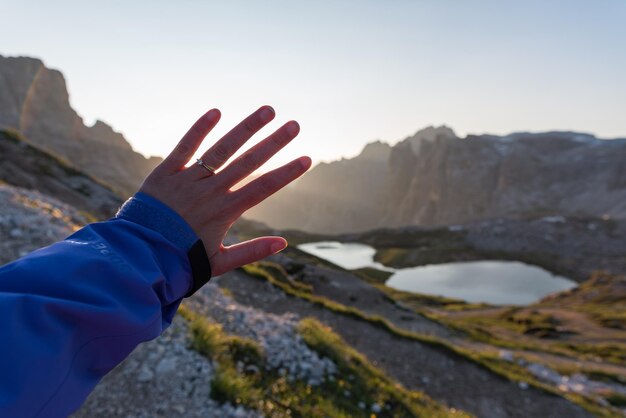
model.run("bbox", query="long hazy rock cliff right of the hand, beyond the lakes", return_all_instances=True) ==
[247,127,626,233]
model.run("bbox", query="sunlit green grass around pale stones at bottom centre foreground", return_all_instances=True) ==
[179,306,468,418]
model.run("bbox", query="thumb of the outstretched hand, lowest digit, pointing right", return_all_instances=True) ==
[211,237,287,276]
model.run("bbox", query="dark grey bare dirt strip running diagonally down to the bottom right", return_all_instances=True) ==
[212,271,592,418]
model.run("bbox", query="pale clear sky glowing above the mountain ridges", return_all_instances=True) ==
[0,0,626,168]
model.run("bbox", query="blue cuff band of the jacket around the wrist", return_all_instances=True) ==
[115,192,198,252]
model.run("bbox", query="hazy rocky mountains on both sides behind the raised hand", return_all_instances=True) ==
[0,56,626,233]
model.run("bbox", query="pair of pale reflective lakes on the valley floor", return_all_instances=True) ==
[298,241,577,305]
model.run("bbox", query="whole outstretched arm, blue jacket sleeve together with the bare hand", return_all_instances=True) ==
[0,108,308,417]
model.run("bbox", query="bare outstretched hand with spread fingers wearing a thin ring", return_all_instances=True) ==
[139,106,311,276]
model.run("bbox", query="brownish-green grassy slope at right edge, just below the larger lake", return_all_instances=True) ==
[414,274,626,365]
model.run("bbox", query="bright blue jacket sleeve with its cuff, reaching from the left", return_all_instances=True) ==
[0,193,198,417]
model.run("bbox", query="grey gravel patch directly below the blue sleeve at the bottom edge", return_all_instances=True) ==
[73,317,261,418]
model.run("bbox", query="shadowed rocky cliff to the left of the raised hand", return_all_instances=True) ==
[0,56,160,195]
